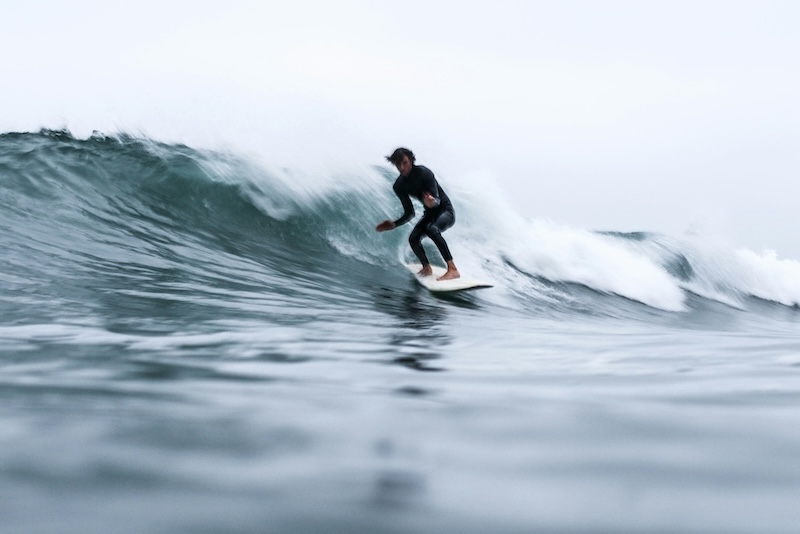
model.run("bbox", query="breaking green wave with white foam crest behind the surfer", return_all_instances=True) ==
[0,131,800,323]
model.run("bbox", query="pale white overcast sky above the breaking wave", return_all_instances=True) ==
[0,0,800,260]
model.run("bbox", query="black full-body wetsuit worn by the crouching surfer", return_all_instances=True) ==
[394,165,456,265]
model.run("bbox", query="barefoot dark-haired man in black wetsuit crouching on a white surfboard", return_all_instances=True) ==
[375,148,461,280]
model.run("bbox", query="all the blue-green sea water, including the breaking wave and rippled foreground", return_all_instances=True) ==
[0,130,800,533]
